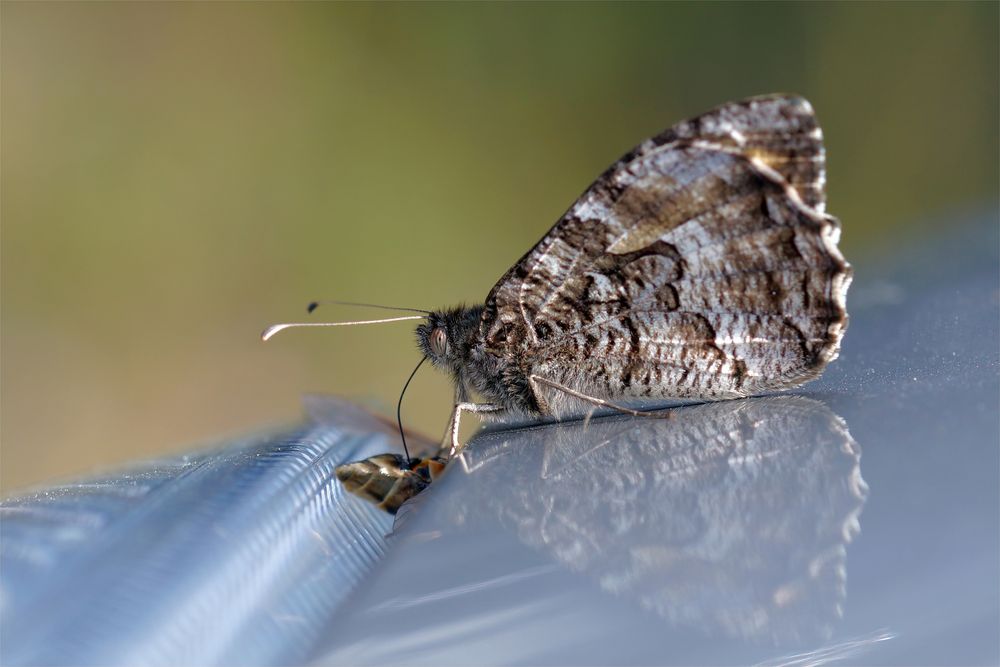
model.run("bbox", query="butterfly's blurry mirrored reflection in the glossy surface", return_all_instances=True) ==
[430,397,867,642]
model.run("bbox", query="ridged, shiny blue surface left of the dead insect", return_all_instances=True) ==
[0,404,398,665]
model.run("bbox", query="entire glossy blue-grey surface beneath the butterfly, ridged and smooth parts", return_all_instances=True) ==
[0,214,1000,665]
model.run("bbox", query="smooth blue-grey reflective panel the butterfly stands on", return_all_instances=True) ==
[317,213,1000,665]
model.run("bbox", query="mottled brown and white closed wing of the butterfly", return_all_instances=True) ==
[481,96,851,398]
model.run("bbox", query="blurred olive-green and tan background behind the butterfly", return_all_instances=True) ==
[0,1,1000,492]
